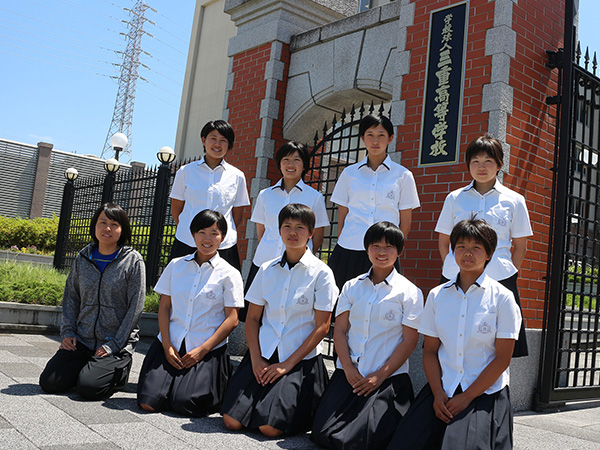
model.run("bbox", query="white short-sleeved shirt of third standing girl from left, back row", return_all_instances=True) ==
[331,156,420,250]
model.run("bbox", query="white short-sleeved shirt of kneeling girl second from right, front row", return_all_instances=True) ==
[336,269,423,376]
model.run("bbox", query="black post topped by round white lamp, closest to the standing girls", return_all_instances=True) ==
[146,147,175,286]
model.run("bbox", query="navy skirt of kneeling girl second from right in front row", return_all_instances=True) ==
[311,369,414,450]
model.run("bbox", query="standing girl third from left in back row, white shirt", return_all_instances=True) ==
[329,115,419,288]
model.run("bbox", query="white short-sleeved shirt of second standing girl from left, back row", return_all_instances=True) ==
[250,180,329,266]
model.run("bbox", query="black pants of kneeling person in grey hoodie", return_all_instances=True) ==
[40,342,132,400]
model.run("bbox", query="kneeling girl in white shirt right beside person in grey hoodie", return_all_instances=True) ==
[137,209,244,417]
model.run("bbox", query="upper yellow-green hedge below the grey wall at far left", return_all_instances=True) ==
[0,216,58,252]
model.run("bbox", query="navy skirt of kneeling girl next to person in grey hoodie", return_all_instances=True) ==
[137,338,232,417]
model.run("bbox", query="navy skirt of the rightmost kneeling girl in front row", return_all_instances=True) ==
[387,383,513,450]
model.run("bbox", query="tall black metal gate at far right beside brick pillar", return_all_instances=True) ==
[537,2,600,408]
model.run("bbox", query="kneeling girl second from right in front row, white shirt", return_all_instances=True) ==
[311,222,423,450]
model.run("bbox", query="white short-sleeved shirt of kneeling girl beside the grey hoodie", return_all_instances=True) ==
[154,253,244,351]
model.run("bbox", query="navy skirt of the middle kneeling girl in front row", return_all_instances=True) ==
[221,352,328,434]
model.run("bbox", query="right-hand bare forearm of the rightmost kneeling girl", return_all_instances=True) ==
[446,338,515,418]
